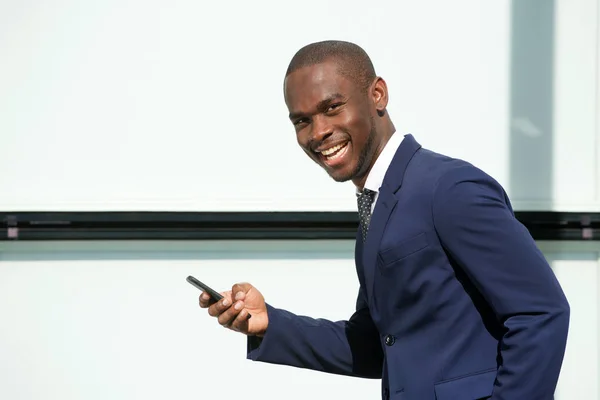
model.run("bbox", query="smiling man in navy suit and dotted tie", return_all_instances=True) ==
[200,41,569,400]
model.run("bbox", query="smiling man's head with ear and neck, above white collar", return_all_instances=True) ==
[284,44,384,188]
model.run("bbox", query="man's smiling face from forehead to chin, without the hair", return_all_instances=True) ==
[285,61,379,183]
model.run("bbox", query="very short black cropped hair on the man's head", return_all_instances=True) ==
[285,40,377,90]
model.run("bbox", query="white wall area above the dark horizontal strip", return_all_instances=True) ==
[0,0,600,211]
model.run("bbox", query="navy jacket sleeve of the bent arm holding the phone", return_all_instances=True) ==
[247,290,383,379]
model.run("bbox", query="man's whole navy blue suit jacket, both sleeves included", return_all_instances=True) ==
[248,135,569,400]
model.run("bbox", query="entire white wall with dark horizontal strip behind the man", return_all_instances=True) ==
[0,0,600,400]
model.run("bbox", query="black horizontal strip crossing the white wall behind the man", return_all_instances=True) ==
[0,211,600,240]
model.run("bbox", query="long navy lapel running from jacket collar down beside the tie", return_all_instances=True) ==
[362,135,421,304]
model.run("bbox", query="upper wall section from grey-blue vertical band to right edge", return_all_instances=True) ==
[507,0,600,211]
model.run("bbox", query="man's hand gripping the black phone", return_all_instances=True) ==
[200,283,269,337]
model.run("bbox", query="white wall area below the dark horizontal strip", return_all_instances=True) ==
[0,241,600,400]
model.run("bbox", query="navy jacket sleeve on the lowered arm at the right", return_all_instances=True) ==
[433,166,570,400]
